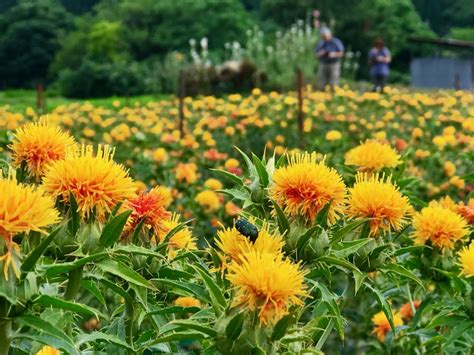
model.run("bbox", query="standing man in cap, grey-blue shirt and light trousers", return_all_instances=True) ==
[316,27,344,89]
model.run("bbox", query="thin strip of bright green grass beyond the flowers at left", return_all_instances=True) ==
[0,90,171,112]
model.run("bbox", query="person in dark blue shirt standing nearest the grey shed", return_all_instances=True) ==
[369,38,392,91]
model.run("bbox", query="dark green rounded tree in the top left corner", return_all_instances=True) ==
[0,0,71,87]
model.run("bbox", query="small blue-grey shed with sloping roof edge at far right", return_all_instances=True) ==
[410,38,474,91]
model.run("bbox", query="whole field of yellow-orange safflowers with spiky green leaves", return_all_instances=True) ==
[0,87,474,355]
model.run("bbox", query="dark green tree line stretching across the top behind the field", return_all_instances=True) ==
[0,0,474,96]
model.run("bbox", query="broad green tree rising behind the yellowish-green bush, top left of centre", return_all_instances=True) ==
[98,0,252,60]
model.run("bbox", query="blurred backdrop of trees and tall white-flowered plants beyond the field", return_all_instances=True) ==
[0,0,474,98]
